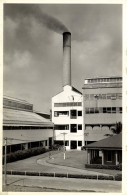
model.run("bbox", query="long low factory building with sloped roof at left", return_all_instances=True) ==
[3,96,53,153]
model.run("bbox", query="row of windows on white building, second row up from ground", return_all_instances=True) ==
[54,124,82,133]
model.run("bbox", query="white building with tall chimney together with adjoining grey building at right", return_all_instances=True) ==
[52,32,122,150]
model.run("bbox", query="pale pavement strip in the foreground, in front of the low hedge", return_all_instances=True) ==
[2,175,121,193]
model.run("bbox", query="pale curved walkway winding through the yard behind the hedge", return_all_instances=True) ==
[37,154,109,175]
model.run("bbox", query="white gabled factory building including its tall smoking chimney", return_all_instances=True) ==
[52,32,84,150]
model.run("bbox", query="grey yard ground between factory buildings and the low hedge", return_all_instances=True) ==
[7,151,121,175]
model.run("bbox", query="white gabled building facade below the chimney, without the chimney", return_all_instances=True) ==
[52,85,84,150]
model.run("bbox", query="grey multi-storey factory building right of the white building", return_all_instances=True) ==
[83,77,122,144]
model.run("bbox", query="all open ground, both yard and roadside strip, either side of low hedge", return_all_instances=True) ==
[3,151,121,192]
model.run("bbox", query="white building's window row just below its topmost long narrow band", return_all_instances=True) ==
[54,110,82,118]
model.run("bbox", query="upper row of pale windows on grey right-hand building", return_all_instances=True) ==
[84,93,122,101]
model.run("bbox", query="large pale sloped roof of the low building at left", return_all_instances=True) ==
[3,108,53,126]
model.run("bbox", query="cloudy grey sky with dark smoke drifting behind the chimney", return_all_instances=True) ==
[4,4,122,113]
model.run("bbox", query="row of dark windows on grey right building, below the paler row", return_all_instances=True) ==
[85,107,122,114]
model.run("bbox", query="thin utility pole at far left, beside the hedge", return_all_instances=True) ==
[4,138,7,186]
